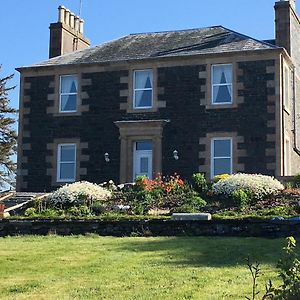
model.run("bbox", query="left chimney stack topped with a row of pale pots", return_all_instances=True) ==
[49,6,90,58]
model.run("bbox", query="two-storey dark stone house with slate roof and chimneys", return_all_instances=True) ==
[17,0,300,191]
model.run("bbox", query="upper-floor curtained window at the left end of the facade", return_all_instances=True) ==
[59,75,78,113]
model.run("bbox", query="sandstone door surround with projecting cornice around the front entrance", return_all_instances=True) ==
[115,120,169,183]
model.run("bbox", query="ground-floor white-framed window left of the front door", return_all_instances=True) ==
[57,144,76,182]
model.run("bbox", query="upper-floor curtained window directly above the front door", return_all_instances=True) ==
[133,70,153,108]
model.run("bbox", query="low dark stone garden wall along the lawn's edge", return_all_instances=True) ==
[0,220,300,238]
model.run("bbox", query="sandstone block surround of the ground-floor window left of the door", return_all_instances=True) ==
[46,138,89,187]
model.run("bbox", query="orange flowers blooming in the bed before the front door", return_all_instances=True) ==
[141,174,185,193]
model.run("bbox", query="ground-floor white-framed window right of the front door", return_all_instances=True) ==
[211,137,232,178]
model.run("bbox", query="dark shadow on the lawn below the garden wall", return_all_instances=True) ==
[119,237,285,267]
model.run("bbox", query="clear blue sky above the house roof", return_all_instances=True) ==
[0,0,290,107]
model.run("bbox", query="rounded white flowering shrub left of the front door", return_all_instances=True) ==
[47,181,112,205]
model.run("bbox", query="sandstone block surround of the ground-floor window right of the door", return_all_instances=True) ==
[199,132,246,179]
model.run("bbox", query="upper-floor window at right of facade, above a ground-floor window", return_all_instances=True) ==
[212,64,232,104]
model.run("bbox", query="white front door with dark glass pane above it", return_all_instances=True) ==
[133,140,153,180]
